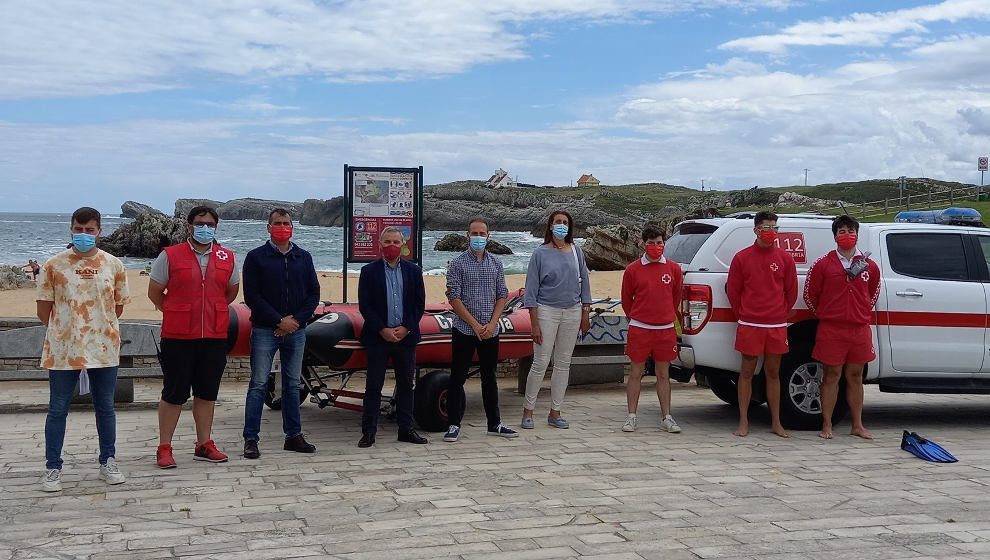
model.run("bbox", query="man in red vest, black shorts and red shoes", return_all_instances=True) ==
[148,206,240,469]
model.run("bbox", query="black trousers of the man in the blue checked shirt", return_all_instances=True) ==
[447,328,502,429]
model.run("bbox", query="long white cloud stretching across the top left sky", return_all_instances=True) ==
[0,0,800,99]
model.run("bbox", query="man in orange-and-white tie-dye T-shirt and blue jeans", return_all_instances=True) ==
[36,207,128,492]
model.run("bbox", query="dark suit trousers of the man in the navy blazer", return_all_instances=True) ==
[361,342,416,435]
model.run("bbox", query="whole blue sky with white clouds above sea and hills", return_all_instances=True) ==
[0,0,990,213]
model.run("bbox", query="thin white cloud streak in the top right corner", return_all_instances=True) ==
[720,0,990,54]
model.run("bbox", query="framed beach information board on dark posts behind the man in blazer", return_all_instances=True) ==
[343,164,423,303]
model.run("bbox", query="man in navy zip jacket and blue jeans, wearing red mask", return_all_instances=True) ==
[241,208,320,459]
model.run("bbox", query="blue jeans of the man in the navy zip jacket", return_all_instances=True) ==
[244,328,306,440]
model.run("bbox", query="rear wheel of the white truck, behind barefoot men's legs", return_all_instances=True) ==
[780,345,847,430]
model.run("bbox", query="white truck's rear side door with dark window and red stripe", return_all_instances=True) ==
[877,231,987,377]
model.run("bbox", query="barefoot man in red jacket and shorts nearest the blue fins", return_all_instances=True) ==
[804,216,880,439]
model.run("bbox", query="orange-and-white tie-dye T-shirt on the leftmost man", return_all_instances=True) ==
[36,249,130,370]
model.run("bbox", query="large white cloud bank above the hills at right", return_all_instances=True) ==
[613,32,990,186]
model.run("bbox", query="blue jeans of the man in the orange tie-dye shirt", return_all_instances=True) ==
[45,366,117,469]
